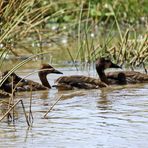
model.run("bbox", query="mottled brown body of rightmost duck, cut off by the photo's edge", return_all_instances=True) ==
[106,71,148,84]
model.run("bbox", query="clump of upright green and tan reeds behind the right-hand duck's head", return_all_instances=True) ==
[70,3,148,71]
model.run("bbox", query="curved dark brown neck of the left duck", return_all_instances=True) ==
[39,71,51,88]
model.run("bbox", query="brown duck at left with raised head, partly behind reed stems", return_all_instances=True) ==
[1,64,62,92]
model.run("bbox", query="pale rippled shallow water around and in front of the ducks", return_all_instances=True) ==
[0,68,148,148]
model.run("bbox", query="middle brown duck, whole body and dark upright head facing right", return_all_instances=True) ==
[54,58,122,90]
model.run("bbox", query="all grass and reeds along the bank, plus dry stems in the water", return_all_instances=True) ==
[0,0,148,126]
